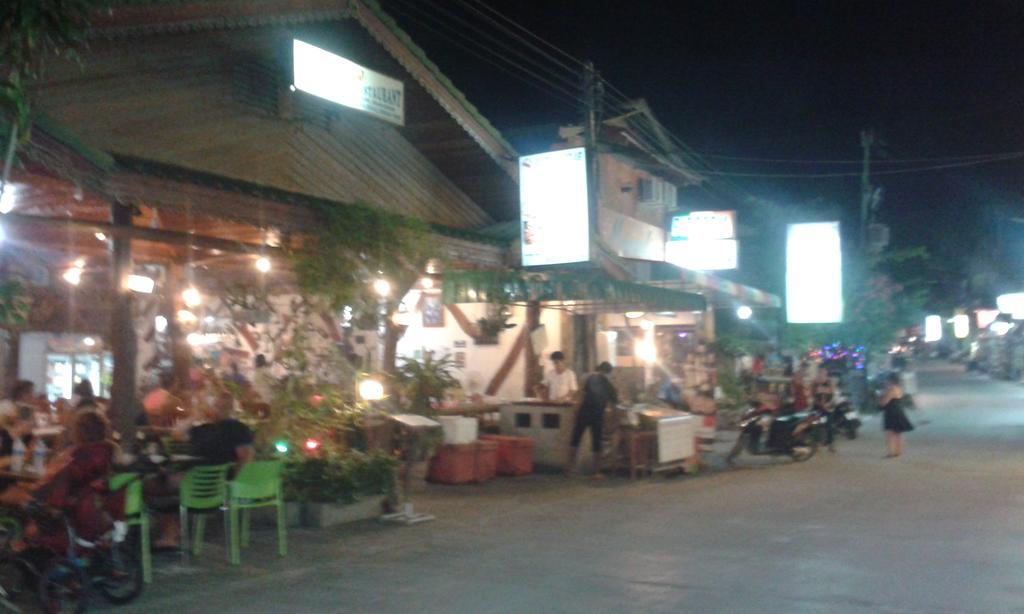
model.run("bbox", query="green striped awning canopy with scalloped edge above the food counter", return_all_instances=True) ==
[442,271,706,313]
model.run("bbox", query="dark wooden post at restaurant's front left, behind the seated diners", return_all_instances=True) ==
[110,203,139,442]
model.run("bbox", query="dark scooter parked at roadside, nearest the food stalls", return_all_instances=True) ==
[725,407,825,465]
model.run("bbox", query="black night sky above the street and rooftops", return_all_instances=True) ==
[383,0,1024,302]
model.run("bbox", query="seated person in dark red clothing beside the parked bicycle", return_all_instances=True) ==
[0,411,117,539]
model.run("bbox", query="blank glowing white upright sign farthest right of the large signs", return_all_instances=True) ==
[785,222,843,323]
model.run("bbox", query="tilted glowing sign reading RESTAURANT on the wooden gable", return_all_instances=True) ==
[292,40,406,126]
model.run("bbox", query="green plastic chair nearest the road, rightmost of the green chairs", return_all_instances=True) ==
[227,461,288,565]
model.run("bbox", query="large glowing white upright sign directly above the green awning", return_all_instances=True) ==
[519,147,590,266]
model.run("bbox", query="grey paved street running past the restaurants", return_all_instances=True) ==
[123,365,1024,614]
